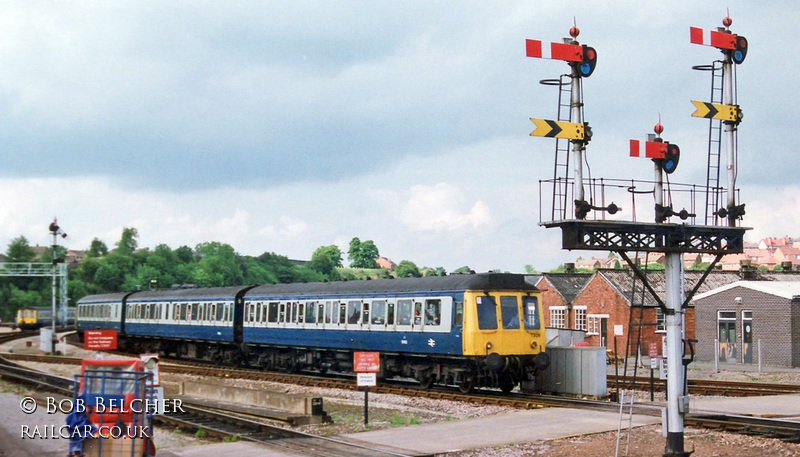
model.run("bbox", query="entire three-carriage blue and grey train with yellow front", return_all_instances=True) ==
[77,273,549,392]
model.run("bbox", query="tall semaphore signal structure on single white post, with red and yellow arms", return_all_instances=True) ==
[526,17,747,457]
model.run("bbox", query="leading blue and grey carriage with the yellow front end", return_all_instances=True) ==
[243,274,548,391]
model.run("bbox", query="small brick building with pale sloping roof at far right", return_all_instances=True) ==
[694,282,800,367]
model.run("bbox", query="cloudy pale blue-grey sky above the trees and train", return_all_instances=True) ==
[0,0,800,272]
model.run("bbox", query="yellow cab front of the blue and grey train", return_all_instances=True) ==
[463,290,550,392]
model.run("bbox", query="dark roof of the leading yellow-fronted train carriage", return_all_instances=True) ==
[247,273,538,298]
